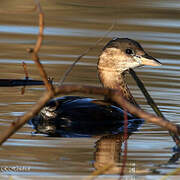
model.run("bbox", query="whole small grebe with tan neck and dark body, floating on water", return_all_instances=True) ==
[29,37,161,137]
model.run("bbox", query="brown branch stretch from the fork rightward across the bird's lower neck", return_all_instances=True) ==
[55,85,180,135]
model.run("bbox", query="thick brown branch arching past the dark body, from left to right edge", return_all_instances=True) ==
[0,85,180,145]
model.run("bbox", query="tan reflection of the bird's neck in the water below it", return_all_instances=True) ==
[94,133,135,174]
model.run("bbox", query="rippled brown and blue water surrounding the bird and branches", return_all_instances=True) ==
[0,0,180,177]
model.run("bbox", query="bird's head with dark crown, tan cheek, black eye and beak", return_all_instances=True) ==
[98,38,161,73]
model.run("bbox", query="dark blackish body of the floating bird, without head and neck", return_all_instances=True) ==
[31,96,143,137]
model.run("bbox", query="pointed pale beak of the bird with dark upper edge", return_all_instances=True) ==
[140,54,162,66]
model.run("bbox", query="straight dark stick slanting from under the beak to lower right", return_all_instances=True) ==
[129,69,180,147]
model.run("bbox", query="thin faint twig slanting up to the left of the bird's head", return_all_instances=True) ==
[59,23,114,85]
